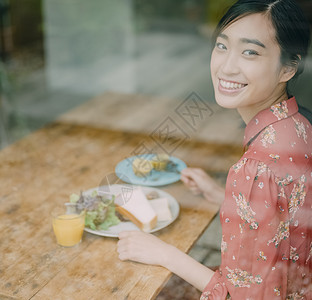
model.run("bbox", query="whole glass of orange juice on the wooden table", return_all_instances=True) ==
[52,206,85,247]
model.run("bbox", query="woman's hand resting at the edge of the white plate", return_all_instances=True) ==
[117,231,172,266]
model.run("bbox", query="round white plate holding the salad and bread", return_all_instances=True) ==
[84,184,180,237]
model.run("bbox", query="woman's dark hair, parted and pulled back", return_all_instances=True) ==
[214,0,310,86]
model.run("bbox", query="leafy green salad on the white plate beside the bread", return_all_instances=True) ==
[70,191,120,230]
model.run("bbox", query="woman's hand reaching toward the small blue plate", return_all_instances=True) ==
[181,168,225,204]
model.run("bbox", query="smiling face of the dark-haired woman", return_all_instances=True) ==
[211,14,286,108]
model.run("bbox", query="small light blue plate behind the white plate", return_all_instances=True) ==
[115,154,186,186]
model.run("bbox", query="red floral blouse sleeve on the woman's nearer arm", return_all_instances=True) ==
[201,158,289,300]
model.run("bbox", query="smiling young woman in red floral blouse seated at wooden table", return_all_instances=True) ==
[118,0,312,300]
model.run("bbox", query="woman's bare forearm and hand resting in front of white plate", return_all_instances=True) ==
[117,231,214,291]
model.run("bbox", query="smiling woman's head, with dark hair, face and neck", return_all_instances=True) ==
[211,1,310,123]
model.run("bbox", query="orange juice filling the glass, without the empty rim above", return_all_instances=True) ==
[53,213,84,247]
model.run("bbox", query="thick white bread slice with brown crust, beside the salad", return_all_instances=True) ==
[115,187,157,232]
